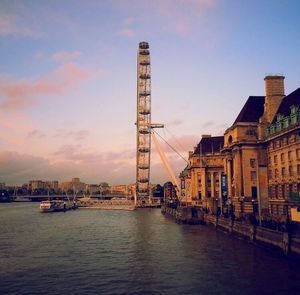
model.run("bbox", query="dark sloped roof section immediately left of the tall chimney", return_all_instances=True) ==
[233,96,265,124]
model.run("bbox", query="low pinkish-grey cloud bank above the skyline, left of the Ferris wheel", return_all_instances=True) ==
[0,145,135,185]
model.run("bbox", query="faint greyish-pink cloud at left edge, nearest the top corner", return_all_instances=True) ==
[0,13,38,37]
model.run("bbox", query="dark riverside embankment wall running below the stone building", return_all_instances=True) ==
[162,206,300,256]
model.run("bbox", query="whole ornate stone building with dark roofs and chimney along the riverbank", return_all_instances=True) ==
[180,75,300,220]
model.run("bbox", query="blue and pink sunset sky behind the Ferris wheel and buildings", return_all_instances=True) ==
[0,0,300,185]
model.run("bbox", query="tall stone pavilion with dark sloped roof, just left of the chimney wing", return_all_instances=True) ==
[222,96,268,216]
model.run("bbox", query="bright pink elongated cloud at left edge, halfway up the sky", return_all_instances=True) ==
[0,63,90,110]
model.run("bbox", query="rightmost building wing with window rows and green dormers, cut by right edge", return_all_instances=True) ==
[264,88,300,217]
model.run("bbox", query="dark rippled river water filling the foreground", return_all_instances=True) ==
[0,203,300,295]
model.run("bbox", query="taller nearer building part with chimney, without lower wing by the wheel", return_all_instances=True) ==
[222,75,300,221]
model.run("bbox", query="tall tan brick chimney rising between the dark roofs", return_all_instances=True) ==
[263,75,285,123]
